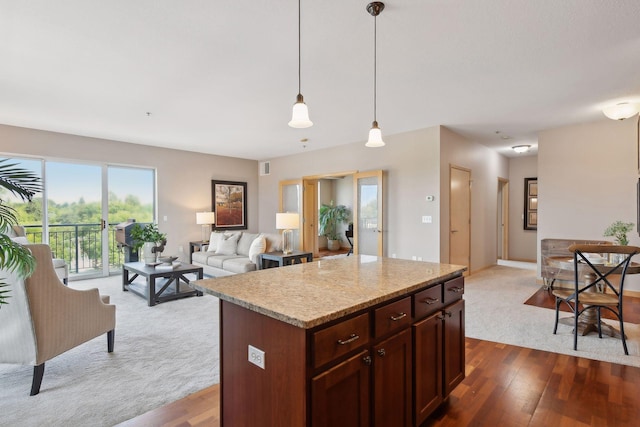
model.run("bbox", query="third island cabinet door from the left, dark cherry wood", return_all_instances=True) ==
[413,311,443,425]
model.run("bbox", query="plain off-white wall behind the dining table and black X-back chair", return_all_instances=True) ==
[538,117,640,289]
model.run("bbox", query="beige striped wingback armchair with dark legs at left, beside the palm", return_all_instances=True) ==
[0,245,116,396]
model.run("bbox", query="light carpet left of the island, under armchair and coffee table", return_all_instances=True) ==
[0,276,219,426]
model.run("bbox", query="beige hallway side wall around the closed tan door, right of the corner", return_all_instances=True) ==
[440,127,509,271]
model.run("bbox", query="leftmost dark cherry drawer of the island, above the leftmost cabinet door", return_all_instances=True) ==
[313,313,370,368]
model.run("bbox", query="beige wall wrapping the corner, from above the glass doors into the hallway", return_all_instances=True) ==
[260,126,508,270]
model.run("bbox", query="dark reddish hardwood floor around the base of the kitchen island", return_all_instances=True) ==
[115,338,640,427]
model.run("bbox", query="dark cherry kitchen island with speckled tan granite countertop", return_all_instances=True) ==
[194,256,466,427]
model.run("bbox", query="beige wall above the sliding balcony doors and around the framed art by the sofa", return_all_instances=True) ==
[0,125,260,260]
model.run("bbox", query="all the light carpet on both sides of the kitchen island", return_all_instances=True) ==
[0,266,640,426]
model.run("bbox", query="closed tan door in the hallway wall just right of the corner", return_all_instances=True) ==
[449,166,471,271]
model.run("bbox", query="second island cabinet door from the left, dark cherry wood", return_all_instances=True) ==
[373,329,412,427]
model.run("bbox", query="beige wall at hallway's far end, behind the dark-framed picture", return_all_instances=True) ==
[509,156,538,262]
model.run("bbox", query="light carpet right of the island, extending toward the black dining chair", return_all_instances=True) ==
[464,266,640,367]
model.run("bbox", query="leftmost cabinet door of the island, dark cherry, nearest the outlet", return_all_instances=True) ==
[311,351,371,427]
